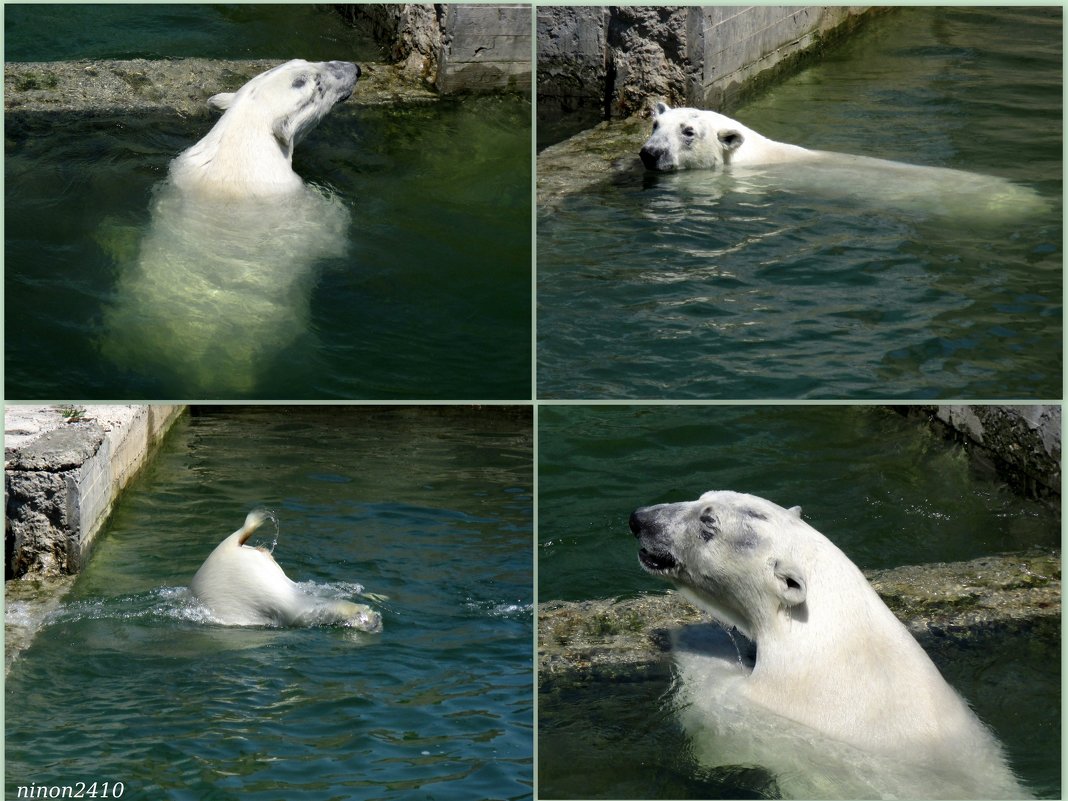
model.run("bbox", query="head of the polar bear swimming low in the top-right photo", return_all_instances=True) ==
[640,103,763,172]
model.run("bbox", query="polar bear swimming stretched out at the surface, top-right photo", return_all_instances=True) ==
[639,103,1050,219]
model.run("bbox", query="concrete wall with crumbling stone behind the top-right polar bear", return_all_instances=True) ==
[537,5,868,144]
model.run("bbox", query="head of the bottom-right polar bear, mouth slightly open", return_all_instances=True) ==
[630,491,820,640]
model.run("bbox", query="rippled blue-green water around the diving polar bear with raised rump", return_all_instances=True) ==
[5,407,533,801]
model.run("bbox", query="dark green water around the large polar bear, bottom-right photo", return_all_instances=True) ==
[537,406,1061,798]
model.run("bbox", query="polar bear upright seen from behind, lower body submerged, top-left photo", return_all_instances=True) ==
[101,60,360,397]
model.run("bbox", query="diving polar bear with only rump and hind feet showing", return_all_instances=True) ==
[189,509,382,631]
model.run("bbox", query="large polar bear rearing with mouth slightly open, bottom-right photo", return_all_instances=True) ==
[630,491,1027,799]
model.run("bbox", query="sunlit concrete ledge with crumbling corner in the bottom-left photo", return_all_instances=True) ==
[4,406,186,579]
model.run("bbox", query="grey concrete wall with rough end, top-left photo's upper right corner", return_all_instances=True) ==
[342,3,533,94]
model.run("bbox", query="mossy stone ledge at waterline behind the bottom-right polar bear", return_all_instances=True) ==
[538,551,1061,685]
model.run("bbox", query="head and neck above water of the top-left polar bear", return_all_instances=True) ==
[171,59,360,198]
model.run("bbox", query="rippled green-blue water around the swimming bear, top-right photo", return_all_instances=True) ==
[537,7,1063,398]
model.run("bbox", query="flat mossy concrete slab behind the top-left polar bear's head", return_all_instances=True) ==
[3,59,438,116]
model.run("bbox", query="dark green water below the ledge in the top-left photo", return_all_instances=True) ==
[5,16,531,399]
